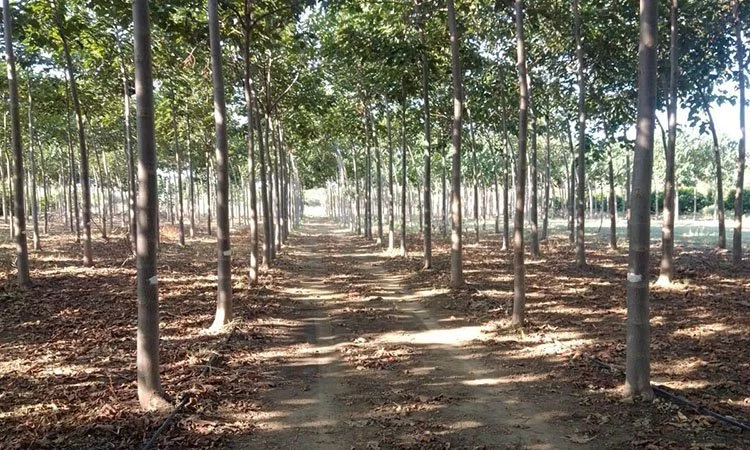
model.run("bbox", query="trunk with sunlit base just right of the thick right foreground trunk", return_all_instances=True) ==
[657,0,679,285]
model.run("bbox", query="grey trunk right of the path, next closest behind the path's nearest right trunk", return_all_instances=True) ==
[446,0,464,288]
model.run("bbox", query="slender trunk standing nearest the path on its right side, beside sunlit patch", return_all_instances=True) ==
[511,0,532,326]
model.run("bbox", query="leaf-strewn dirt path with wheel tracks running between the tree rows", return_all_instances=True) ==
[230,222,603,449]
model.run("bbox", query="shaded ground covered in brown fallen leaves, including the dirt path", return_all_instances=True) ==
[0,220,750,449]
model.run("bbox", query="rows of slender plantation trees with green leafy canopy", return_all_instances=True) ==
[2,0,748,406]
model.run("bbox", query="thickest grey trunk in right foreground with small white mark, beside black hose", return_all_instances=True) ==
[624,0,659,400]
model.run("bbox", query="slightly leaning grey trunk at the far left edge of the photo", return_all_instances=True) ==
[3,0,31,288]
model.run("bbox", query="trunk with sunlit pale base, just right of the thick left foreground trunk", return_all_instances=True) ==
[208,0,233,329]
